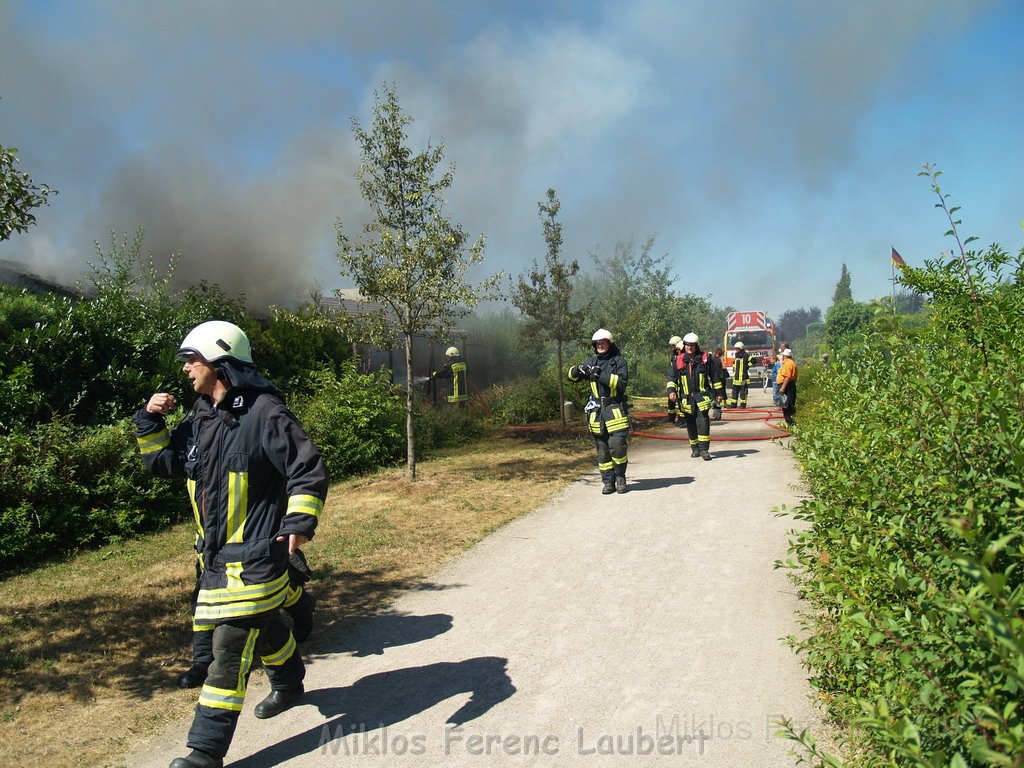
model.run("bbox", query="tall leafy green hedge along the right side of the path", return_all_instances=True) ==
[787,167,1024,768]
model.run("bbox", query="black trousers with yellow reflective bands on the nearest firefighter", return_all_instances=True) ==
[187,610,306,758]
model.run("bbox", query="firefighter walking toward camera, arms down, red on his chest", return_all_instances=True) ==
[666,333,724,462]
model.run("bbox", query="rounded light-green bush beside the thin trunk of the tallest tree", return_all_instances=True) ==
[292,360,406,480]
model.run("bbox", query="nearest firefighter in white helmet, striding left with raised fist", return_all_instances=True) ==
[133,321,328,768]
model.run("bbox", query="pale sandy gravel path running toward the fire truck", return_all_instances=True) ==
[127,390,816,768]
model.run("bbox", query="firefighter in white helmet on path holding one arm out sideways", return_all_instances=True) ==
[568,328,630,494]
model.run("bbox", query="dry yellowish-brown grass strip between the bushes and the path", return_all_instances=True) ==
[0,430,593,766]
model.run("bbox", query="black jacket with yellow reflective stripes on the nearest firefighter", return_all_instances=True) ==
[132,389,328,625]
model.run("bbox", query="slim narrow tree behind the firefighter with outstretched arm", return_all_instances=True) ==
[511,188,584,427]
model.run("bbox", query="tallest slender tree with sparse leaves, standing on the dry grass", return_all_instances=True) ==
[335,86,500,480]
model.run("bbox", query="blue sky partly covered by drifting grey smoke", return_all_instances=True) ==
[0,0,1024,325]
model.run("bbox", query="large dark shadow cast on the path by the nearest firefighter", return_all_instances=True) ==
[231,656,516,768]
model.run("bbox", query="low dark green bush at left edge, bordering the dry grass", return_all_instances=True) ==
[0,419,180,570]
